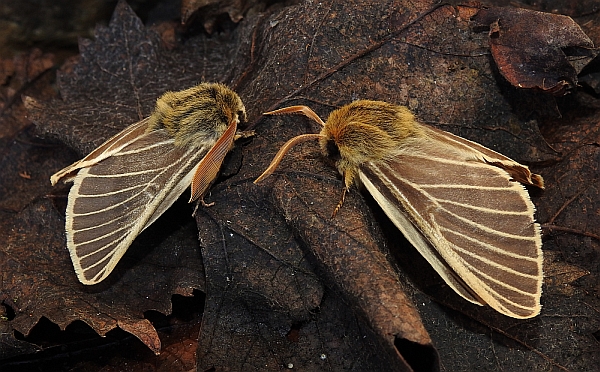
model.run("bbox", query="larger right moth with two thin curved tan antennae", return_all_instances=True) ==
[255,100,544,318]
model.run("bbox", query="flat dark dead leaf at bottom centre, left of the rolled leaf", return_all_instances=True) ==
[192,179,426,370]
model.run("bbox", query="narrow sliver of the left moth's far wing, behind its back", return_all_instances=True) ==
[50,118,148,186]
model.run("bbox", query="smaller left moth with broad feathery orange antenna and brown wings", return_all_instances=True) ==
[50,83,246,285]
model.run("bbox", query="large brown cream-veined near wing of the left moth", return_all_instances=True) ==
[66,130,209,285]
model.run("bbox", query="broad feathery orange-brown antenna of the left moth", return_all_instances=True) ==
[190,120,237,203]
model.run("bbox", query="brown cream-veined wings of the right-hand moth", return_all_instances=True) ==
[360,127,542,318]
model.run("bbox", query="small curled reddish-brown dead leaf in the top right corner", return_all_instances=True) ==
[473,7,598,95]
